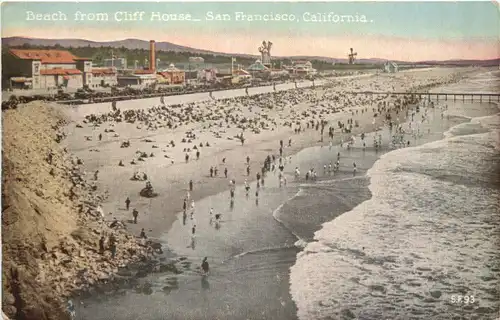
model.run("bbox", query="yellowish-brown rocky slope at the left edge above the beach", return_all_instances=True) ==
[2,102,143,320]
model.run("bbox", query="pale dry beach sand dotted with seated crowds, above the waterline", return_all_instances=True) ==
[64,69,468,237]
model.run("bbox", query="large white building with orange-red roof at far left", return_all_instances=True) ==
[2,49,92,90]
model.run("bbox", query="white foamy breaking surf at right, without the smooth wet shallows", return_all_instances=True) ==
[291,70,500,320]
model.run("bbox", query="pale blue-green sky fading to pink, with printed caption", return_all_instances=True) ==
[1,1,500,61]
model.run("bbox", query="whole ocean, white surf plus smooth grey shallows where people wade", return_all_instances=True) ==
[78,73,500,320]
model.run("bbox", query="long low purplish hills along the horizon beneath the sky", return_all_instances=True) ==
[2,37,500,66]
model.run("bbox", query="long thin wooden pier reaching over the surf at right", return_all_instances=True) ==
[345,91,500,102]
